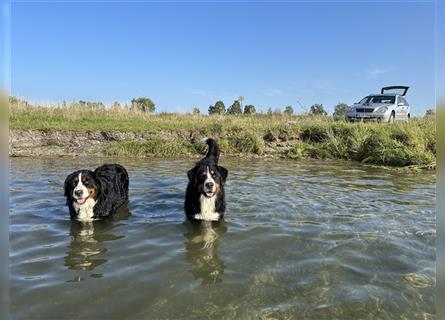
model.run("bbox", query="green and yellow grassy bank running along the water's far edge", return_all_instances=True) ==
[10,100,436,167]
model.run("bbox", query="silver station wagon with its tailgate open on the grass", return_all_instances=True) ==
[346,86,411,122]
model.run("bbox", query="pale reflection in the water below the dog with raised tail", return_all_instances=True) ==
[184,221,227,284]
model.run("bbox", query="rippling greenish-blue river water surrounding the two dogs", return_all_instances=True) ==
[10,158,436,319]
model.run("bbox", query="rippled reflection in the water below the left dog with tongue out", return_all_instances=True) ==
[64,206,130,271]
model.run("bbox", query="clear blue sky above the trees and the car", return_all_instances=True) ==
[11,2,435,115]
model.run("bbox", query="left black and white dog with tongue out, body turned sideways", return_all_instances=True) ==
[65,164,129,221]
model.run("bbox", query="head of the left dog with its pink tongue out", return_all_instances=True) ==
[64,170,100,206]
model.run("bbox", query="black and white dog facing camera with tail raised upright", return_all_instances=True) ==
[184,138,228,221]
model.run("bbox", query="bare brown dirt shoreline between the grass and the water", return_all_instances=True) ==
[9,129,436,173]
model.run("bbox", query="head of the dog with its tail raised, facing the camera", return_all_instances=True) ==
[187,160,228,198]
